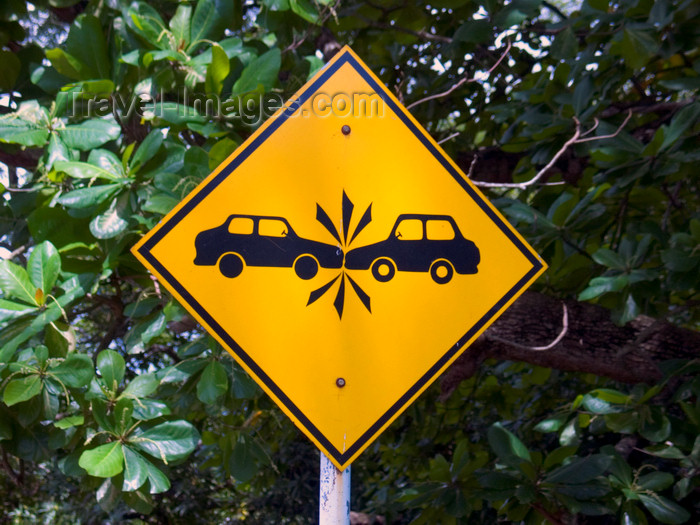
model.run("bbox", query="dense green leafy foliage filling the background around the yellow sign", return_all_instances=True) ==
[0,0,700,524]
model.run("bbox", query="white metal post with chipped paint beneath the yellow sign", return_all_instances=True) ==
[318,452,350,525]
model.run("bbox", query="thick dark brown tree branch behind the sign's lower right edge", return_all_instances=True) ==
[442,292,700,396]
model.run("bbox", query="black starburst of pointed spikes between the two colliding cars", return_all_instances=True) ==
[306,191,372,319]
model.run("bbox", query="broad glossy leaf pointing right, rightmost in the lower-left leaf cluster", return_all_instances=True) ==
[132,420,199,462]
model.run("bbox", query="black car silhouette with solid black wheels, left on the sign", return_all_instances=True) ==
[194,215,343,279]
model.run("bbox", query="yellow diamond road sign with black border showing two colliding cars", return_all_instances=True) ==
[134,47,546,469]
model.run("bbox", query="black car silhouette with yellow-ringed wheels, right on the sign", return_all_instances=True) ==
[345,213,481,284]
